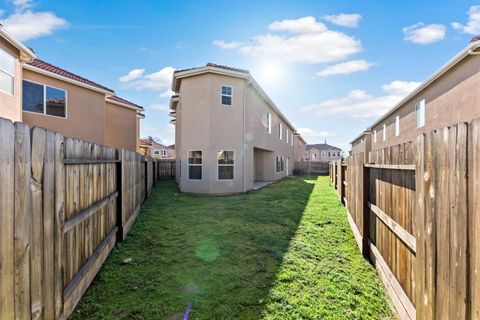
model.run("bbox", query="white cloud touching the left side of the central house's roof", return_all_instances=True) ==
[118,67,175,91]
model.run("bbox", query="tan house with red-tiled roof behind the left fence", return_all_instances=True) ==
[0,26,143,151]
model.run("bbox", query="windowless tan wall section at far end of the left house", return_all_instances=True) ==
[105,102,138,152]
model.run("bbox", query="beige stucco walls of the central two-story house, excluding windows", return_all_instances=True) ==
[175,73,293,194]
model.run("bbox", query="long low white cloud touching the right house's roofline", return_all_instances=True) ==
[301,80,420,118]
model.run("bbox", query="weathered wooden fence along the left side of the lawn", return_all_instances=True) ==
[0,118,161,320]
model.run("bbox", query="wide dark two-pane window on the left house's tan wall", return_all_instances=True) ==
[22,80,67,118]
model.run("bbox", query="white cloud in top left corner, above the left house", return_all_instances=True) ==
[3,10,68,41]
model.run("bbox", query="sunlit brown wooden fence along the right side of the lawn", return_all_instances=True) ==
[331,119,480,319]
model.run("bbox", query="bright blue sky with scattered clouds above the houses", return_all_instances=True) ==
[0,0,480,149]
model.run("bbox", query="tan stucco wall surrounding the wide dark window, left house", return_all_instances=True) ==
[23,69,105,144]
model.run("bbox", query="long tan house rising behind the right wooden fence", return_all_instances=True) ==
[352,38,480,154]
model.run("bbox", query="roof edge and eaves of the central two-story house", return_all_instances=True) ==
[170,62,296,132]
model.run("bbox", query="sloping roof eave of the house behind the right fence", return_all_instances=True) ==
[368,37,480,129]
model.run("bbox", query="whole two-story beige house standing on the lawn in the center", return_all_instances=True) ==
[170,63,295,194]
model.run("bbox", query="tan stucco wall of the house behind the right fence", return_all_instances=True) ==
[372,56,480,150]
